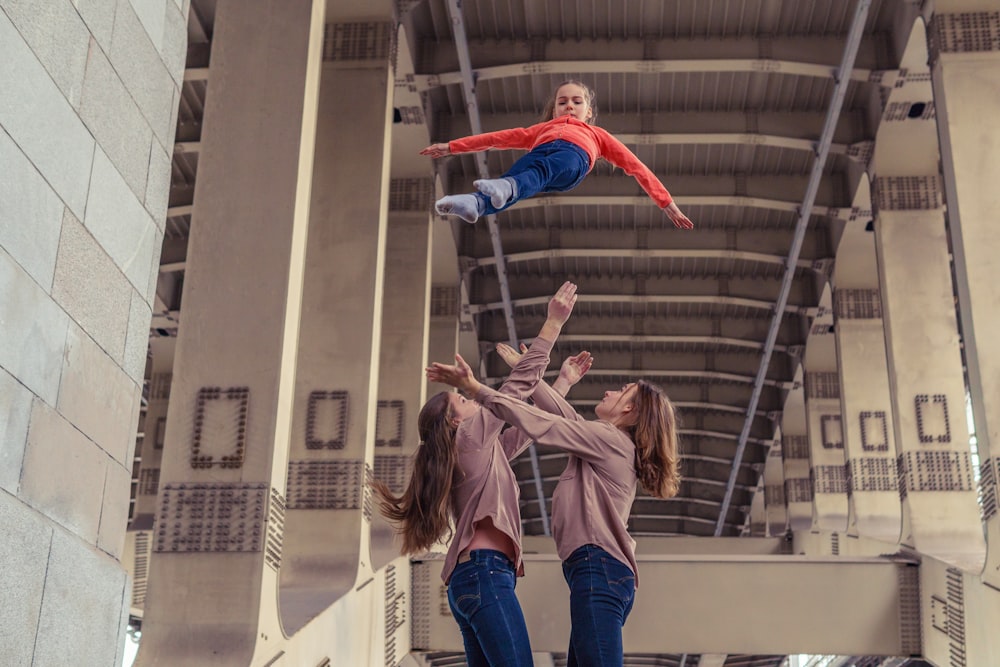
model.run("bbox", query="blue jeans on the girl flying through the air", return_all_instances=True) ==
[476,139,590,215]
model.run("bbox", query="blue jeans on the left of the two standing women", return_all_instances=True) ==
[448,549,534,667]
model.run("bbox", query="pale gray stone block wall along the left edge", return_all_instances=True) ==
[0,0,189,665]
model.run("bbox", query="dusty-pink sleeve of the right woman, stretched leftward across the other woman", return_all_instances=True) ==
[475,387,634,462]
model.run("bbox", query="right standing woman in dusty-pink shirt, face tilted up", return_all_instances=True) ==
[427,348,680,667]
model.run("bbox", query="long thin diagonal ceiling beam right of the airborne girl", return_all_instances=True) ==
[715,0,871,536]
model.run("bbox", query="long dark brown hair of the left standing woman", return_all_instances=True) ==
[372,391,457,554]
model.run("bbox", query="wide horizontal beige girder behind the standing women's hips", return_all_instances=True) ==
[411,552,920,656]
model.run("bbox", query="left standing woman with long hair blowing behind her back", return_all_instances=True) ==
[374,282,582,667]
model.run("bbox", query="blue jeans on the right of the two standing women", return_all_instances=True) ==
[563,544,635,667]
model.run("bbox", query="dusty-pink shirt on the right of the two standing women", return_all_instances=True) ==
[475,380,639,587]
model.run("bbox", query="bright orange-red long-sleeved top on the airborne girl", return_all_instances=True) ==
[448,116,673,208]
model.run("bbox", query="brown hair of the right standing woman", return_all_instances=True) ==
[627,380,680,498]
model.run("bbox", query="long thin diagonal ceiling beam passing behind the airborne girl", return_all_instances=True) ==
[448,0,551,535]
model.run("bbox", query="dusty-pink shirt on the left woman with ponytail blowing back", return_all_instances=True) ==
[441,338,552,583]
